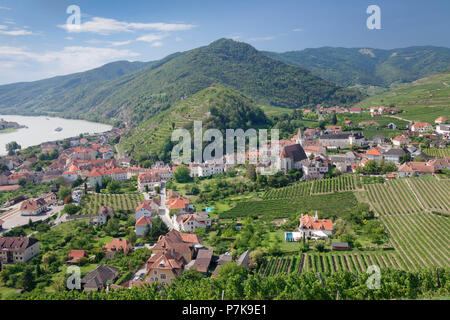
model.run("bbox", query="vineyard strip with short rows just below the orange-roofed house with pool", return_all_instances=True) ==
[258,252,403,276]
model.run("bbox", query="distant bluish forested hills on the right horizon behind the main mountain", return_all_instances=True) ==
[265,46,450,87]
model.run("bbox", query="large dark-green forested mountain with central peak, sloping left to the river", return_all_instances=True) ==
[0,39,363,123]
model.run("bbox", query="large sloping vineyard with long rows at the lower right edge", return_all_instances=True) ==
[365,178,450,270]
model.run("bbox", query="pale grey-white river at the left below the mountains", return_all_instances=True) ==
[0,115,112,155]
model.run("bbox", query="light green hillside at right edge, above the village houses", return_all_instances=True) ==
[358,73,450,124]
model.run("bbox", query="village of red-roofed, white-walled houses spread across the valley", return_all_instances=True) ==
[0,106,450,291]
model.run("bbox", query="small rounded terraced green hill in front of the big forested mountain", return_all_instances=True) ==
[119,86,268,161]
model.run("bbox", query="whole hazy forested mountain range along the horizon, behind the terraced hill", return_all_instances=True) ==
[0,39,450,124]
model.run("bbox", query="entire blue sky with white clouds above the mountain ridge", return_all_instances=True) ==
[0,0,450,84]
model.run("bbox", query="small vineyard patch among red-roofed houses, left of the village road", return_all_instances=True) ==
[80,193,144,215]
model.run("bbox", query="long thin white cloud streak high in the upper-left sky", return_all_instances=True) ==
[58,17,194,35]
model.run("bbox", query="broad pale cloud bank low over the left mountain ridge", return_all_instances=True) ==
[0,46,139,80]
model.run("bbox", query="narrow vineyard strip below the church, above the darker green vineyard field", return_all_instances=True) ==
[263,175,357,200]
